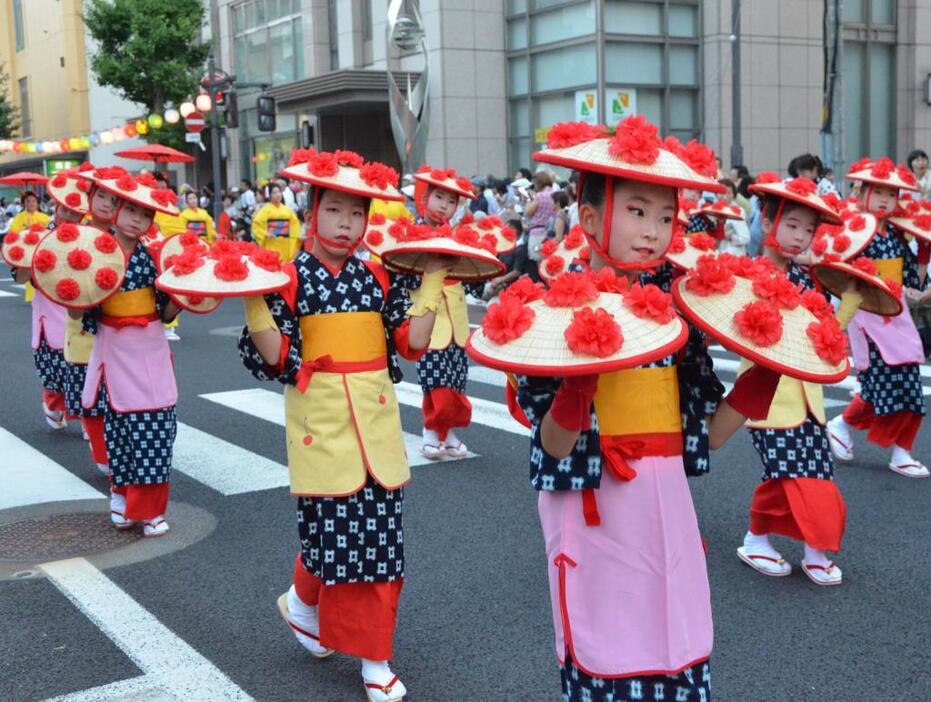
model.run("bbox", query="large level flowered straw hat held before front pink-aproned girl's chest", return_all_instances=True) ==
[466,272,688,376]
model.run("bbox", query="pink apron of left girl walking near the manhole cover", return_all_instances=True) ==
[81,320,178,412]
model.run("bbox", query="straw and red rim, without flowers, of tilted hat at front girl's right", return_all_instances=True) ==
[672,274,850,384]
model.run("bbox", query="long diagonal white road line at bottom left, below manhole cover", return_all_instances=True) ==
[39,558,253,702]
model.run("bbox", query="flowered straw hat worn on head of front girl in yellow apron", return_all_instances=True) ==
[278,149,404,200]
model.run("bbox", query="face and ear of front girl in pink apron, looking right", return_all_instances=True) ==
[579,180,676,263]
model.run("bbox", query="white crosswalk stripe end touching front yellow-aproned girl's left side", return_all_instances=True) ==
[172,422,288,495]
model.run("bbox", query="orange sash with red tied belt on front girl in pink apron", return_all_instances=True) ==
[595,366,682,480]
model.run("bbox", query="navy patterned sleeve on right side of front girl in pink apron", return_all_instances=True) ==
[678,325,724,476]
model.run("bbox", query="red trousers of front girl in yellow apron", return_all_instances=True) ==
[294,554,404,661]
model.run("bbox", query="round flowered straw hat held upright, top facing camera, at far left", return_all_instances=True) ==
[32,223,126,309]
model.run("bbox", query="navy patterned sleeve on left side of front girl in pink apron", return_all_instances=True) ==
[517,375,601,490]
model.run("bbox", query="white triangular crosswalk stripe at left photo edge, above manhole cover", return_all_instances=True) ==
[0,427,104,510]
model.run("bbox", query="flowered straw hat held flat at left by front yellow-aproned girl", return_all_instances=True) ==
[155,241,290,298]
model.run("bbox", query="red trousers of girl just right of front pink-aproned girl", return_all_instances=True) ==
[750,478,847,551]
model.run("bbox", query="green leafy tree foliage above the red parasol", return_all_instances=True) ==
[84,0,210,143]
